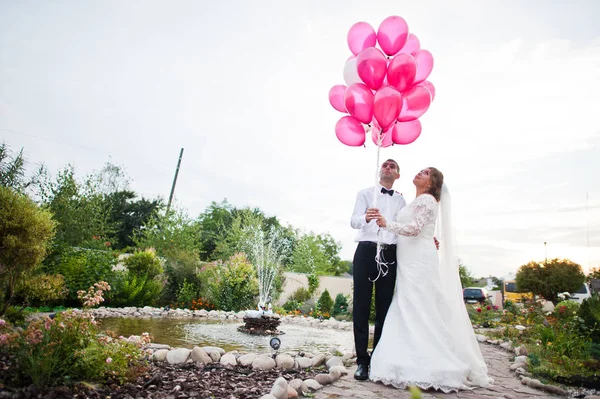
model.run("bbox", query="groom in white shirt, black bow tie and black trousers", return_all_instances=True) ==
[350,159,406,380]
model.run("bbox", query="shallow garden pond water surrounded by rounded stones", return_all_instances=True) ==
[100,318,354,352]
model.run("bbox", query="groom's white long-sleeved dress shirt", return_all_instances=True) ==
[350,184,406,244]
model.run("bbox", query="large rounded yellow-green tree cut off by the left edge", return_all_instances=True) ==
[0,187,55,315]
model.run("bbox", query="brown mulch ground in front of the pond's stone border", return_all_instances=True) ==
[0,358,323,399]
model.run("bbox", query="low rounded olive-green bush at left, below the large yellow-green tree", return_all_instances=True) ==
[16,274,69,306]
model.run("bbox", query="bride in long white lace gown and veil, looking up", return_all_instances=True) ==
[369,168,492,393]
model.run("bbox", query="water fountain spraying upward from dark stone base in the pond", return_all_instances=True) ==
[238,224,289,335]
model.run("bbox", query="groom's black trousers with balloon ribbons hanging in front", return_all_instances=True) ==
[352,242,396,365]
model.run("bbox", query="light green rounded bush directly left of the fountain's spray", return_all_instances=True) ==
[198,253,258,311]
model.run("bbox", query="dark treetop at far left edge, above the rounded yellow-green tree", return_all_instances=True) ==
[0,142,45,192]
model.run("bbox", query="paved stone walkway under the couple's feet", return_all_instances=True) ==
[314,344,560,399]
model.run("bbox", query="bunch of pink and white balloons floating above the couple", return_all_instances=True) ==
[329,16,435,148]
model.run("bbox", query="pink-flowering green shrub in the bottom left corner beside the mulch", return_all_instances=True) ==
[0,282,150,388]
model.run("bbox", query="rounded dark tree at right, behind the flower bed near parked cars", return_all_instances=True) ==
[516,259,585,304]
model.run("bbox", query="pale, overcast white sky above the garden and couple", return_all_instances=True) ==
[0,0,600,277]
